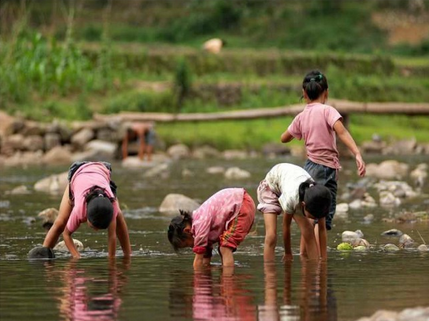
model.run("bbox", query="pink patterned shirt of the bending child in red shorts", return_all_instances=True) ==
[191,188,245,254]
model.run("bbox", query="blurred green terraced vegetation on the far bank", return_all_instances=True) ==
[0,0,429,149]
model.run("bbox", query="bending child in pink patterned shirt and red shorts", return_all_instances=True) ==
[168,188,255,269]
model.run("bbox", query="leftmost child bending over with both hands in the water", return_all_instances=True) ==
[43,162,131,258]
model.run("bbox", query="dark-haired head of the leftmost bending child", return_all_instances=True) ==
[85,186,114,229]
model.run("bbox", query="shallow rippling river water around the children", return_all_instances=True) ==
[0,157,429,321]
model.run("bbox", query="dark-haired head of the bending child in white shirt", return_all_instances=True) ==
[298,179,332,218]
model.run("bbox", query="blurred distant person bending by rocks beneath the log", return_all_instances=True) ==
[122,122,155,161]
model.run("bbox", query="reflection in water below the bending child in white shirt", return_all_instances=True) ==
[258,260,337,321]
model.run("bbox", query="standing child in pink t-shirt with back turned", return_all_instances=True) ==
[281,70,365,252]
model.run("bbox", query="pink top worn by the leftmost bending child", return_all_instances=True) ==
[67,162,120,233]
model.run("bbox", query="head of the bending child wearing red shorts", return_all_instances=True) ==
[168,210,194,251]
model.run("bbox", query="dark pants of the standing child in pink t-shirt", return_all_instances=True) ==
[304,159,337,230]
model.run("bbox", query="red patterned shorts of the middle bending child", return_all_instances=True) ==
[219,191,255,251]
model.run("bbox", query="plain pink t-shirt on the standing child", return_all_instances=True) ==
[288,103,342,169]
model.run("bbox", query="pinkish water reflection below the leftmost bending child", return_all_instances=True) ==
[46,259,130,321]
